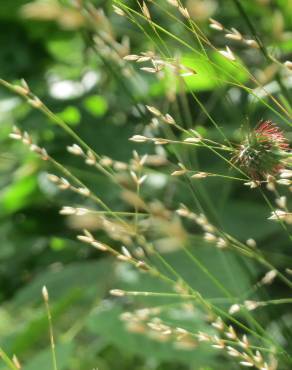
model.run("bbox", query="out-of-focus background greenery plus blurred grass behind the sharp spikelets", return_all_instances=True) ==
[0,0,292,370]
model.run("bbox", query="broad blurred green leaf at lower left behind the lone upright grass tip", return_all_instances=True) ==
[0,259,112,355]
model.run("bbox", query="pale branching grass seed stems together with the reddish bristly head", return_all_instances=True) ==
[1,0,292,370]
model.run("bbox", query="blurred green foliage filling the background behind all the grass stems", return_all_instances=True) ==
[0,0,292,370]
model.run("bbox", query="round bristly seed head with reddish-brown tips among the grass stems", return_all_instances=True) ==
[233,121,291,180]
